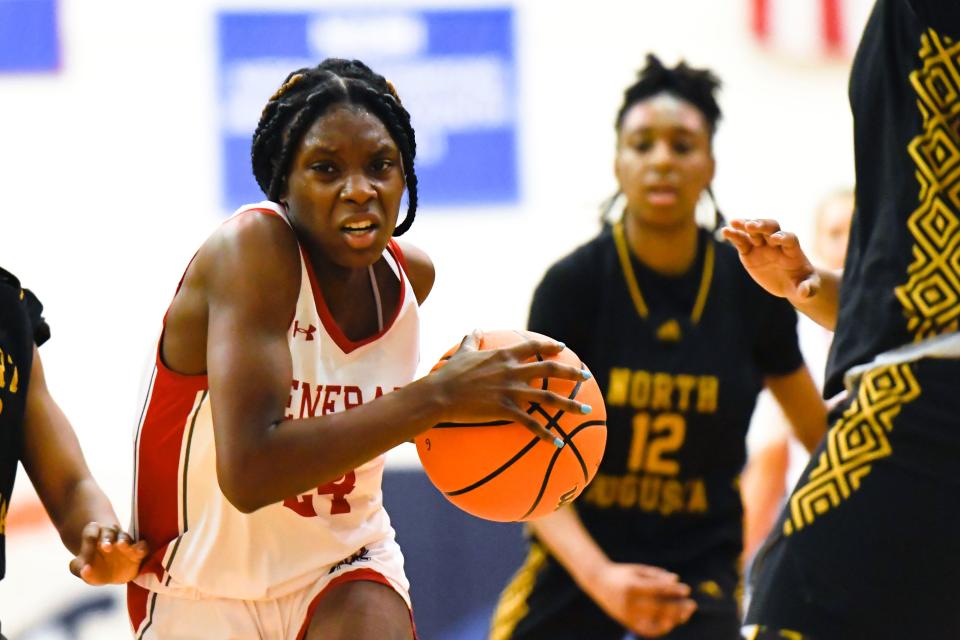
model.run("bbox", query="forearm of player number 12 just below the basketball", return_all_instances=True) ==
[529,505,610,593]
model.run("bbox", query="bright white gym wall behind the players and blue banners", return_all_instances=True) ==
[0,0,853,637]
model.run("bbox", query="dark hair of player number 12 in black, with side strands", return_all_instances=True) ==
[601,53,725,229]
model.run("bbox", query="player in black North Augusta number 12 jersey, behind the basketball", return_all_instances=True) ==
[491,56,826,640]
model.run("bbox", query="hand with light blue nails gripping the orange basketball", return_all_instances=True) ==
[428,331,591,447]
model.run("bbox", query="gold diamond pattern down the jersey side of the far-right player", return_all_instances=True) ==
[894,29,960,342]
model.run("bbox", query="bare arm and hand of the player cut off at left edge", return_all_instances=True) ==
[22,347,147,584]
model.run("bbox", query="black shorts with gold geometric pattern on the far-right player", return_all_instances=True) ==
[746,359,960,640]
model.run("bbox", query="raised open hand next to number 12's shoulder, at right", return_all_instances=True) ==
[723,220,820,305]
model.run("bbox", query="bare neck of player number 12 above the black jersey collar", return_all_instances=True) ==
[624,215,698,275]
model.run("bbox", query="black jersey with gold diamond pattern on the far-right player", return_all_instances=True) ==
[826,0,960,397]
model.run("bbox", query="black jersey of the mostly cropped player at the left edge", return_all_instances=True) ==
[0,268,50,578]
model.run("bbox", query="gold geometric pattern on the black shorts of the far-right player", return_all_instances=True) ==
[783,364,920,536]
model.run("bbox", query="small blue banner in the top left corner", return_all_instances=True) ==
[0,0,60,73]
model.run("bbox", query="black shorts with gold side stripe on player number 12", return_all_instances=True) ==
[490,542,740,640]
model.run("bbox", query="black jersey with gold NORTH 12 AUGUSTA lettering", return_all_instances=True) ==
[529,225,803,567]
